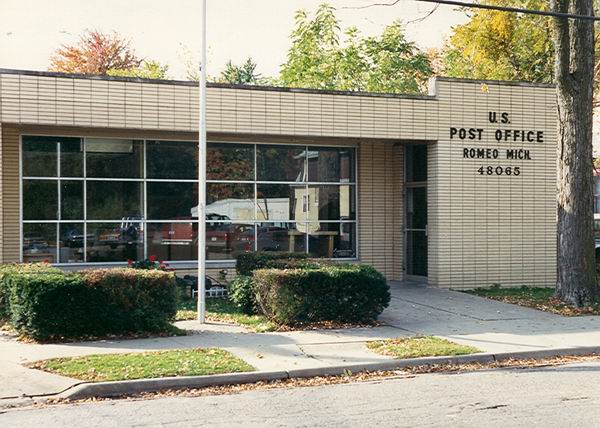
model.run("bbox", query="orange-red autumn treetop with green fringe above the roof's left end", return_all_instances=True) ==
[49,30,167,79]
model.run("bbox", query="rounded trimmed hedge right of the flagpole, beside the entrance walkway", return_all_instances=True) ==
[253,264,390,325]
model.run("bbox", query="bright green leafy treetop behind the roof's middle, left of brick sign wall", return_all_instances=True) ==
[278,4,432,92]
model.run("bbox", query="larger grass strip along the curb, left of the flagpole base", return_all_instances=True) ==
[29,348,254,382]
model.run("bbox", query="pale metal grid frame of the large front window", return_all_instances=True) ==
[19,133,360,267]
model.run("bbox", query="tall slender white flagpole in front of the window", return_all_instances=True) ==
[198,0,206,323]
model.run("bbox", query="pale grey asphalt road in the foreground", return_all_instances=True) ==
[0,362,600,428]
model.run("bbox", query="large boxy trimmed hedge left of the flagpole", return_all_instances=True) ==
[1,265,177,340]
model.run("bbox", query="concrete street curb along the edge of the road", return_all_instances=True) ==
[57,346,600,400]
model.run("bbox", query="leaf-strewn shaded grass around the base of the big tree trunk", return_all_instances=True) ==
[464,287,600,317]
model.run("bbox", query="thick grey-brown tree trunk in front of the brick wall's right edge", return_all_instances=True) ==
[552,0,598,307]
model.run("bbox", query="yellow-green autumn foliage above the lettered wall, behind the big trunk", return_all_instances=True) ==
[439,0,600,107]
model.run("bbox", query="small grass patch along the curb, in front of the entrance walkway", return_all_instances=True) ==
[367,336,481,358]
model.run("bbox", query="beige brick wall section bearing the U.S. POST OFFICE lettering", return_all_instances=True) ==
[429,81,556,288]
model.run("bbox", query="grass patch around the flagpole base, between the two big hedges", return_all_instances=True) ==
[175,298,277,333]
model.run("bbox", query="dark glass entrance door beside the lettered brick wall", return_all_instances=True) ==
[404,144,427,277]
